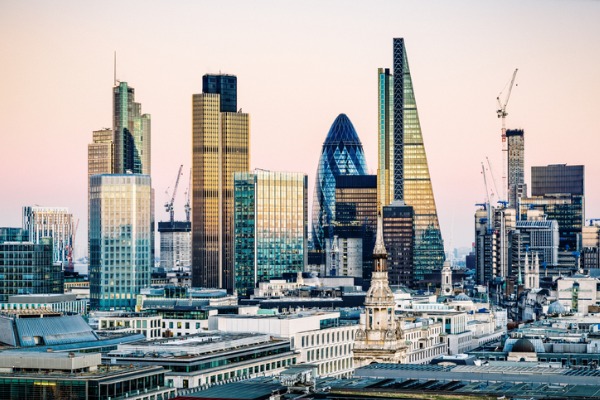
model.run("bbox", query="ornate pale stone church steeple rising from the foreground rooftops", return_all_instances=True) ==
[354,212,407,368]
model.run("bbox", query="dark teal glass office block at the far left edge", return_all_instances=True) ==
[0,234,63,303]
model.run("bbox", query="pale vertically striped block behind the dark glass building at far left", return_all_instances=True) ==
[23,206,74,267]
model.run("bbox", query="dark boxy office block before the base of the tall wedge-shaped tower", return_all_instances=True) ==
[383,202,415,286]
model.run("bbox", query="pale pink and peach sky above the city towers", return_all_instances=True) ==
[0,0,600,257]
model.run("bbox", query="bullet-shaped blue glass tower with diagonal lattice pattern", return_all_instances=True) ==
[312,114,367,250]
